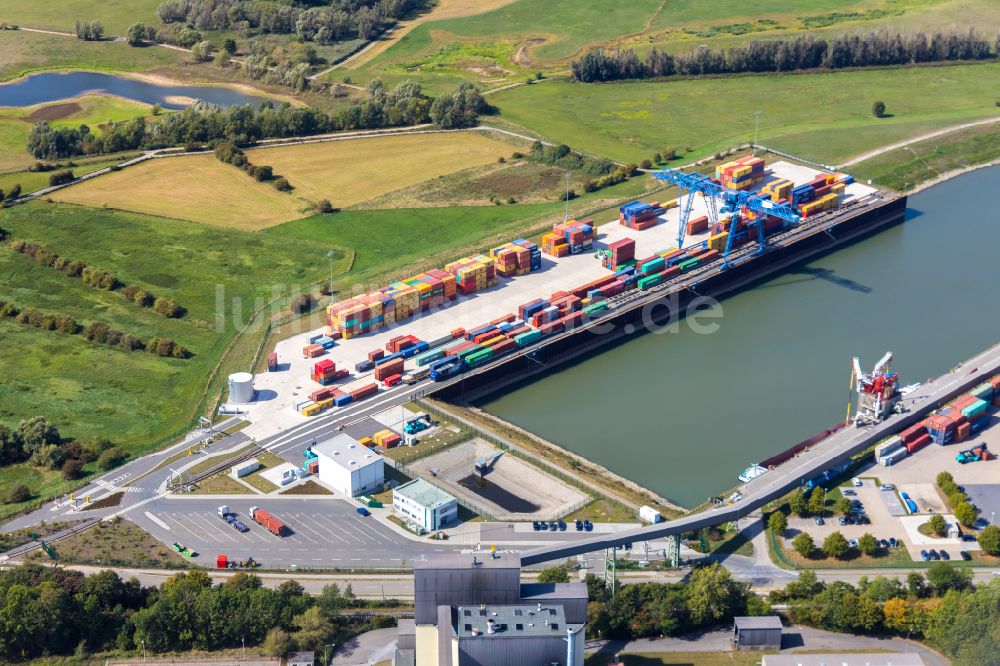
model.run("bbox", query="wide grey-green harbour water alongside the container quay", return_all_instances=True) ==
[483,167,1000,506]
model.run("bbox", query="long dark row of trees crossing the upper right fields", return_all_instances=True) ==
[571,29,1000,83]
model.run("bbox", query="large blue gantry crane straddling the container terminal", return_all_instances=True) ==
[653,169,799,270]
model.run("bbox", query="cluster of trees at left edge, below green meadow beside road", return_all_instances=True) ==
[0,416,127,486]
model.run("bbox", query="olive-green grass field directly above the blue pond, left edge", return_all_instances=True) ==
[0,28,185,81]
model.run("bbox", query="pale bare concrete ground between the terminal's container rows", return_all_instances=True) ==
[241,161,874,439]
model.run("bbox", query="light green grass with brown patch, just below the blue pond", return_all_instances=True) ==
[0,95,151,171]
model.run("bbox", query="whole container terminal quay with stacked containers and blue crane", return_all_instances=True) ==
[242,160,906,438]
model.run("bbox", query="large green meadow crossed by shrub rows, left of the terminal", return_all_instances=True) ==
[0,202,345,462]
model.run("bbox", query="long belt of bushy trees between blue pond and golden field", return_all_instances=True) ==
[27,80,487,160]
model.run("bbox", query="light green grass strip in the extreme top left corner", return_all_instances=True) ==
[0,0,160,36]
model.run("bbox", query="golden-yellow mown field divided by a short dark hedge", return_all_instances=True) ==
[53,133,511,230]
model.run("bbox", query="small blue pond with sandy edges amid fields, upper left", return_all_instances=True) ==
[0,72,267,109]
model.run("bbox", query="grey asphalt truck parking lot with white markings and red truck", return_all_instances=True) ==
[130,497,461,569]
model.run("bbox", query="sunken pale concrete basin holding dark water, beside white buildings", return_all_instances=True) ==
[409,438,588,520]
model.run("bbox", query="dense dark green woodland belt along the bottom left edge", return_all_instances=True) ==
[0,564,398,663]
